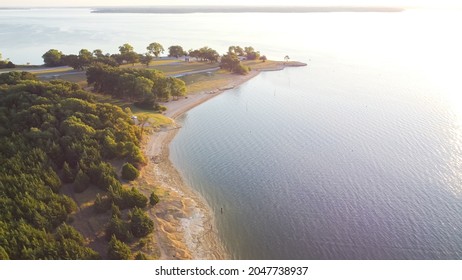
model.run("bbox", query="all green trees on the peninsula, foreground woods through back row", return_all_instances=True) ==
[0,43,266,259]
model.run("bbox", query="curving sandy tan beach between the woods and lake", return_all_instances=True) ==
[141,62,305,259]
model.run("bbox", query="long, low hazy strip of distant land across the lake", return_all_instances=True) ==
[92,6,406,14]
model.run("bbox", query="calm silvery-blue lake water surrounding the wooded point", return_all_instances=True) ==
[0,9,462,259]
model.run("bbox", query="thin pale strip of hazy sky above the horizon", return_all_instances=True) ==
[0,0,461,7]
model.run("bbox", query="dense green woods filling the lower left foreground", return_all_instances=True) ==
[0,72,149,259]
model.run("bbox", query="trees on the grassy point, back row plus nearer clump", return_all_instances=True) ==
[42,42,266,111]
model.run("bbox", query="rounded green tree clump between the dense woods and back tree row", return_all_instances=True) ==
[87,64,186,106]
